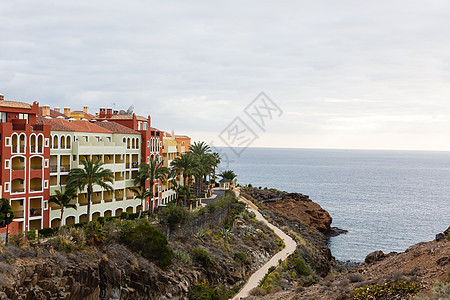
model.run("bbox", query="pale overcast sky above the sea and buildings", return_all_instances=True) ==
[0,0,450,151]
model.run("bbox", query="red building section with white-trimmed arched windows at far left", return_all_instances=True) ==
[0,95,50,233]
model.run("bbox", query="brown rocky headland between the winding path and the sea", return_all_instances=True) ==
[242,188,333,234]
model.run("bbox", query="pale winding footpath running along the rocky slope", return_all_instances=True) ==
[233,191,297,300]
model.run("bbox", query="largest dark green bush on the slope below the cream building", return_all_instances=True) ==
[120,219,173,268]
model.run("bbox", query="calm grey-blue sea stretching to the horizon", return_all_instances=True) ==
[222,148,450,261]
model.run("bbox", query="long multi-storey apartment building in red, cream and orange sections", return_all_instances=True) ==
[0,95,190,235]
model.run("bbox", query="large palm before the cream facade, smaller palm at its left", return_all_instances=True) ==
[67,158,114,223]
